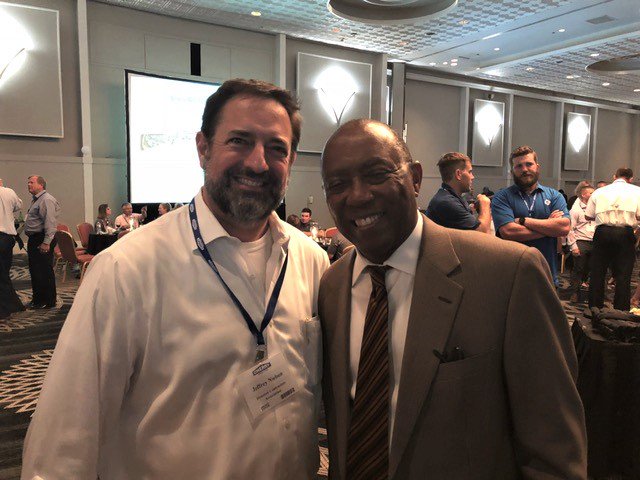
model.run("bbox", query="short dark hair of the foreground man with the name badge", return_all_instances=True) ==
[200,78,302,152]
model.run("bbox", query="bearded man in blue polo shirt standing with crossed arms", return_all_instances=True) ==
[491,146,571,286]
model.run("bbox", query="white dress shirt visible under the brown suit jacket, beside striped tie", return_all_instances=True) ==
[349,214,423,439]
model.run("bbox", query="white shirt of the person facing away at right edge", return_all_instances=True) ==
[585,178,640,228]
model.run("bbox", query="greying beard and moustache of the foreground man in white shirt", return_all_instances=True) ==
[204,170,286,223]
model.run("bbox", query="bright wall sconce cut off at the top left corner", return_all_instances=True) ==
[0,8,33,85]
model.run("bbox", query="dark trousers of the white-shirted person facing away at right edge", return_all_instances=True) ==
[589,225,636,310]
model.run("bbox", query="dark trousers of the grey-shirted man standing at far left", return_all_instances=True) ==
[27,233,56,305]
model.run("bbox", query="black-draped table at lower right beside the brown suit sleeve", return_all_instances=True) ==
[571,317,640,479]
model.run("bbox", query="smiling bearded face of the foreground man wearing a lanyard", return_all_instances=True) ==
[196,96,295,225]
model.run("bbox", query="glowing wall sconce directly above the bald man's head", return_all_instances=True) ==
[314,67,358,125]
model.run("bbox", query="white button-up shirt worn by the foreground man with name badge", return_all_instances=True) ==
[22,193,329,480]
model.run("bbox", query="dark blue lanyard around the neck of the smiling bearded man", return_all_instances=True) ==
[189,198,289,362]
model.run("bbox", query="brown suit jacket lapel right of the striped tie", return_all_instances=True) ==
[389,217,463,478]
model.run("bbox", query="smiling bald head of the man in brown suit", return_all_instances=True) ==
[322,122,422,264]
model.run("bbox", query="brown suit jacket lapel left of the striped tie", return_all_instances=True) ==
[324,250,355,478]
